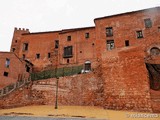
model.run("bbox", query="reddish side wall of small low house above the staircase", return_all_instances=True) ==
[0,52,27,88]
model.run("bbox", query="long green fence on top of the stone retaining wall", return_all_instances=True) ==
[31,65,83,81]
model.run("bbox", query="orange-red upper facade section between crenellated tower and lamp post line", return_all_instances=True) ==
[18,31,59,71]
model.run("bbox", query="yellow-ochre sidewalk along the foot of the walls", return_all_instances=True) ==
[0,106,160,120]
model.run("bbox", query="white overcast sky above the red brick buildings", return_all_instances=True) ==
[0,0,160,51]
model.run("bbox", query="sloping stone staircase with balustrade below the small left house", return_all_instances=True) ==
[0,77,31,98]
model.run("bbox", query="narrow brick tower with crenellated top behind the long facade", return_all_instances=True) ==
[10,28,30,55]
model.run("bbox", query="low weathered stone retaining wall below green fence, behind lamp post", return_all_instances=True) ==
[0,73,103,108]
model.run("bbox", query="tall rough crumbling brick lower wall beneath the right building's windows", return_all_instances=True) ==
[102,47,152,111]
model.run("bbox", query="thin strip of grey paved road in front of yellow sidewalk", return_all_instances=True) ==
[0,116,105,120]
